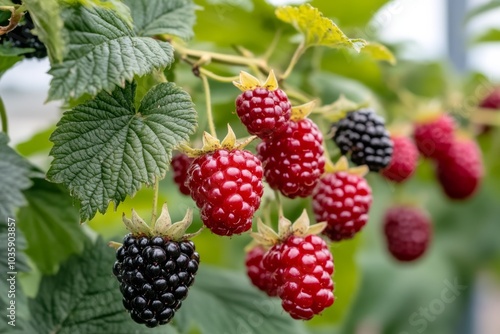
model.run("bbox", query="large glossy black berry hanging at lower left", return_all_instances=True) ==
[113,234,200,327]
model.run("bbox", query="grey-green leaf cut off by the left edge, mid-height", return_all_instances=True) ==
[0,132,31,222]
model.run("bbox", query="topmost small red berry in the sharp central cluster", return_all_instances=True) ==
[236,87,292,139]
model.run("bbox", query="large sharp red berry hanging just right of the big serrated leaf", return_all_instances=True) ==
[187,149,264,235]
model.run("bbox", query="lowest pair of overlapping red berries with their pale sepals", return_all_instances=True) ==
[246,211,334,320]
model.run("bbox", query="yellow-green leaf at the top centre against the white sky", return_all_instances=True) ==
[276,4,366,52]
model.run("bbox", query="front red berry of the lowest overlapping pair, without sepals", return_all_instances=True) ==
[278,235,334,320]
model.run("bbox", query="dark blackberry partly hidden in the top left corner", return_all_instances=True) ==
[0,7,47,59]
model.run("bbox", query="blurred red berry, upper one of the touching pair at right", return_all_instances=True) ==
[414,114,455,159]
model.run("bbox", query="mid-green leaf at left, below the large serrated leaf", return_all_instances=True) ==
[18,179,85,274]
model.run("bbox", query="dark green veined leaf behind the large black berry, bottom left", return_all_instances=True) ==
[30,238,175,334]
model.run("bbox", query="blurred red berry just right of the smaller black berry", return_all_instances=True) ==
[381,136,418,183]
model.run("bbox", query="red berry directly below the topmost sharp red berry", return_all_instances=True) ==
[257,118,325,198]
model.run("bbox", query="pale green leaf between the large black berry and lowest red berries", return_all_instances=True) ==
[175,265,307,334]
